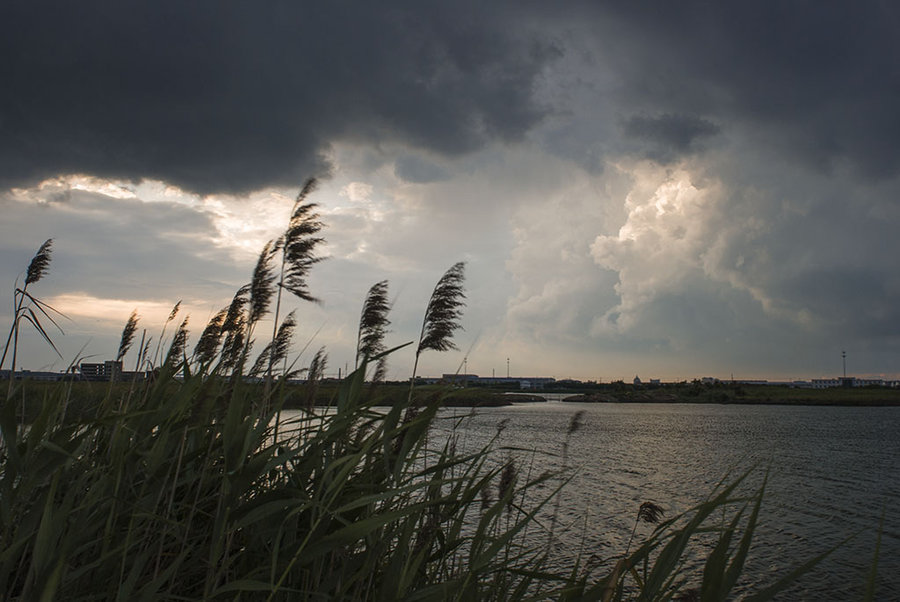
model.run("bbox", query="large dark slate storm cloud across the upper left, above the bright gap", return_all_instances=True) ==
[0,0,556,193]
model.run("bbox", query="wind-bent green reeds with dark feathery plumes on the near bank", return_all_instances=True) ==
[0,187,844,601]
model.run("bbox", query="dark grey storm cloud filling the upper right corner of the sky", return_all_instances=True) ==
[585,1,900,178]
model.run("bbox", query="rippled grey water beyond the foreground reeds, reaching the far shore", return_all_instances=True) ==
[432,402,900,600]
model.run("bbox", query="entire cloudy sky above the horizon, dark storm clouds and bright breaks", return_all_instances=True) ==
[0,0,900,381]
